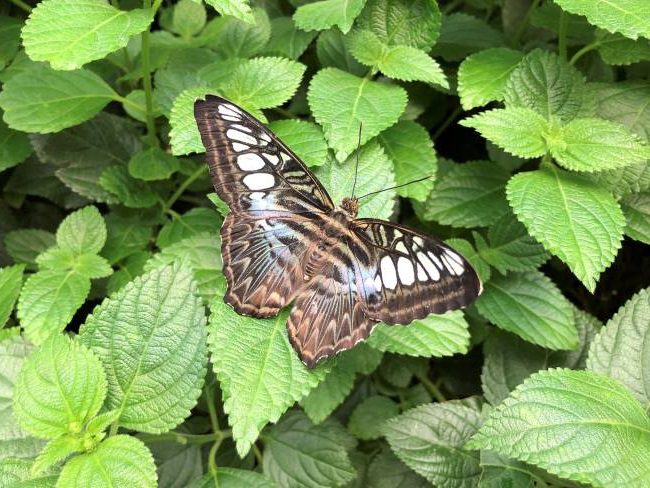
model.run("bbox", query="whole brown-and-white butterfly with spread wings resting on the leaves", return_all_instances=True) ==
[194,95,481,368]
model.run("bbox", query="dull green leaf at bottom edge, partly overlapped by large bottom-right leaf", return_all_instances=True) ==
[384,402,481,487]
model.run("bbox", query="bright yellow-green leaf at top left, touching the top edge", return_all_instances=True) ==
[22,0,153,70]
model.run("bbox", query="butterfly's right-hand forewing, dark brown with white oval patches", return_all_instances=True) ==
[351,219,482,324]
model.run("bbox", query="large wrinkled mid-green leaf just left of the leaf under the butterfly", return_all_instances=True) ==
[79,266,207,433]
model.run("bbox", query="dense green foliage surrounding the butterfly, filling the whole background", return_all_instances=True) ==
[0,0,650,488]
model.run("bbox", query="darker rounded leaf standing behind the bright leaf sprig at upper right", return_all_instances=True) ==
[504,49,585,122]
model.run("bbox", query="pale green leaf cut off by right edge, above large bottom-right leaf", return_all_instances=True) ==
[587,288,650,409]
